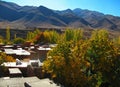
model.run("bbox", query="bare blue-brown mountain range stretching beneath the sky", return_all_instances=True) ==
[0,1,120,30]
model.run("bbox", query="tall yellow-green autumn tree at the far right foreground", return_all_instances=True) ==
[86,30,120,87]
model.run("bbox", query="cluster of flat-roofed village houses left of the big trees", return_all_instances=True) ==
[0,43,60,87]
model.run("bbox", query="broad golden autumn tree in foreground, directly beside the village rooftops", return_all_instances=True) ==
[43,40,91,87]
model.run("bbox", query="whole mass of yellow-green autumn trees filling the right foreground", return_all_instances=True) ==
[44,30,120,87]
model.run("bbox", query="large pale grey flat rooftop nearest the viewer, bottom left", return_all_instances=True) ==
[0,77,61,87]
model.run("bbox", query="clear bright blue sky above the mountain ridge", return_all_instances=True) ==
[3,0,120,16]
